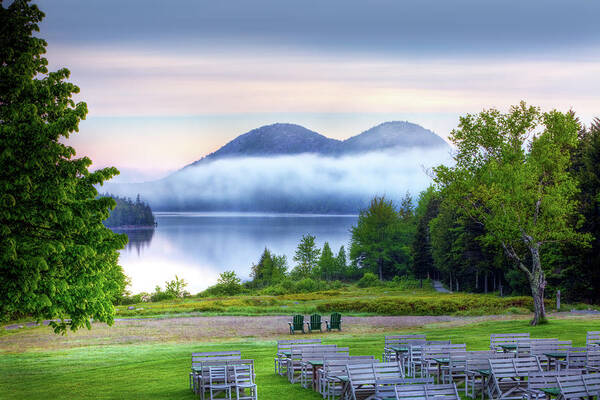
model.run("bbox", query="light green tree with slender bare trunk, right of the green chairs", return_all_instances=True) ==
[434,102,587,325]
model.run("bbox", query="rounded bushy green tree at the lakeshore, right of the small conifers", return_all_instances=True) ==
[350,195,414,280]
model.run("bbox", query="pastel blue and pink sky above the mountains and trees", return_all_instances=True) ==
[35,0,600,182]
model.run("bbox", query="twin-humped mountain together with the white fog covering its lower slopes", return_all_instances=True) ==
[103,122,450,214]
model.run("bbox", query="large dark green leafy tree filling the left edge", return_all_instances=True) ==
[0,0,127,332]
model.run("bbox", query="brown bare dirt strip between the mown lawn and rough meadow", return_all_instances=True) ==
[0,316,476,351]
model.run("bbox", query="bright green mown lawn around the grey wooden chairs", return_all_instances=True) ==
[0,317,600,400]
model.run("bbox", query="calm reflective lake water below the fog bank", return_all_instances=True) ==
[120,213,357,293]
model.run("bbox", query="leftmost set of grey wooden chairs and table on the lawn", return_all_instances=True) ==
[189,350,258,400]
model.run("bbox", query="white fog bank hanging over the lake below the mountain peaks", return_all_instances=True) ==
[106,148,450,212]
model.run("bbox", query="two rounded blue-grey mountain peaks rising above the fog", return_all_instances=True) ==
[187,121,448,167]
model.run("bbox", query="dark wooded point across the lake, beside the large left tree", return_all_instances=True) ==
[100,193,156,228]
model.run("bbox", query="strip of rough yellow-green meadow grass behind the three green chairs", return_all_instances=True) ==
[117,286,536,317]
